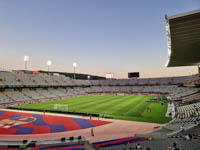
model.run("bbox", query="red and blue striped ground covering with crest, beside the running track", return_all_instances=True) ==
[0,110,111,135]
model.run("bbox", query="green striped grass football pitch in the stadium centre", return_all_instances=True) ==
[15,95,171,123]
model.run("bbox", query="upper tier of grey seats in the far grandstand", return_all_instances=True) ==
[0,72,200,87]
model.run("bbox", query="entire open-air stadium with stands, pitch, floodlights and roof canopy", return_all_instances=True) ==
[0,2,200,150]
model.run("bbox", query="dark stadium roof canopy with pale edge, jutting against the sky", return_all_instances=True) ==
[165,9,200,67]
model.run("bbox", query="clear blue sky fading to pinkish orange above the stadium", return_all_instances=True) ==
[0,0,200,78]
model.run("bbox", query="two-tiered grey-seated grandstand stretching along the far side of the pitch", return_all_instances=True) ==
[0,72,200,104]
